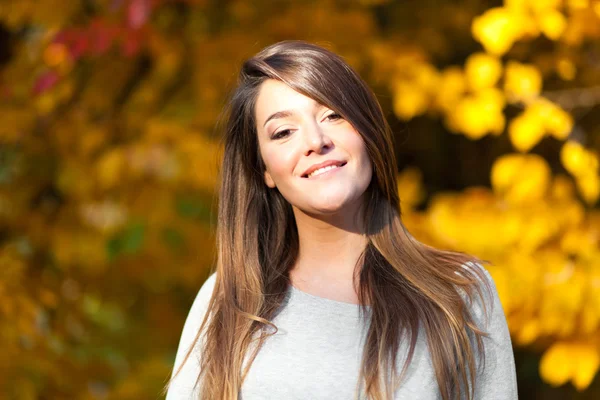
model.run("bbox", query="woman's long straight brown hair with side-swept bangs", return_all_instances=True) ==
[168,41,491,400]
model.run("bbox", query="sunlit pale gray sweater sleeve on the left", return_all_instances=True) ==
[166,274,216,400]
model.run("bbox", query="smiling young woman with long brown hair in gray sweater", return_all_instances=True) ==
[167,41,517,400]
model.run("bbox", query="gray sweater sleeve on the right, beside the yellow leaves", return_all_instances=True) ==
[472,264,518,400]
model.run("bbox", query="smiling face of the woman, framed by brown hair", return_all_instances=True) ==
[255,79,372,215]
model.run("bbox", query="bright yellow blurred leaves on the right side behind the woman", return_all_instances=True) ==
[391,0,600,390]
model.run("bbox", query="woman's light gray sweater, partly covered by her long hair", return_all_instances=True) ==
[167,271,517,400]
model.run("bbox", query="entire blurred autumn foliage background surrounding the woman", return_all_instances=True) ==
[0,0,600,400]
